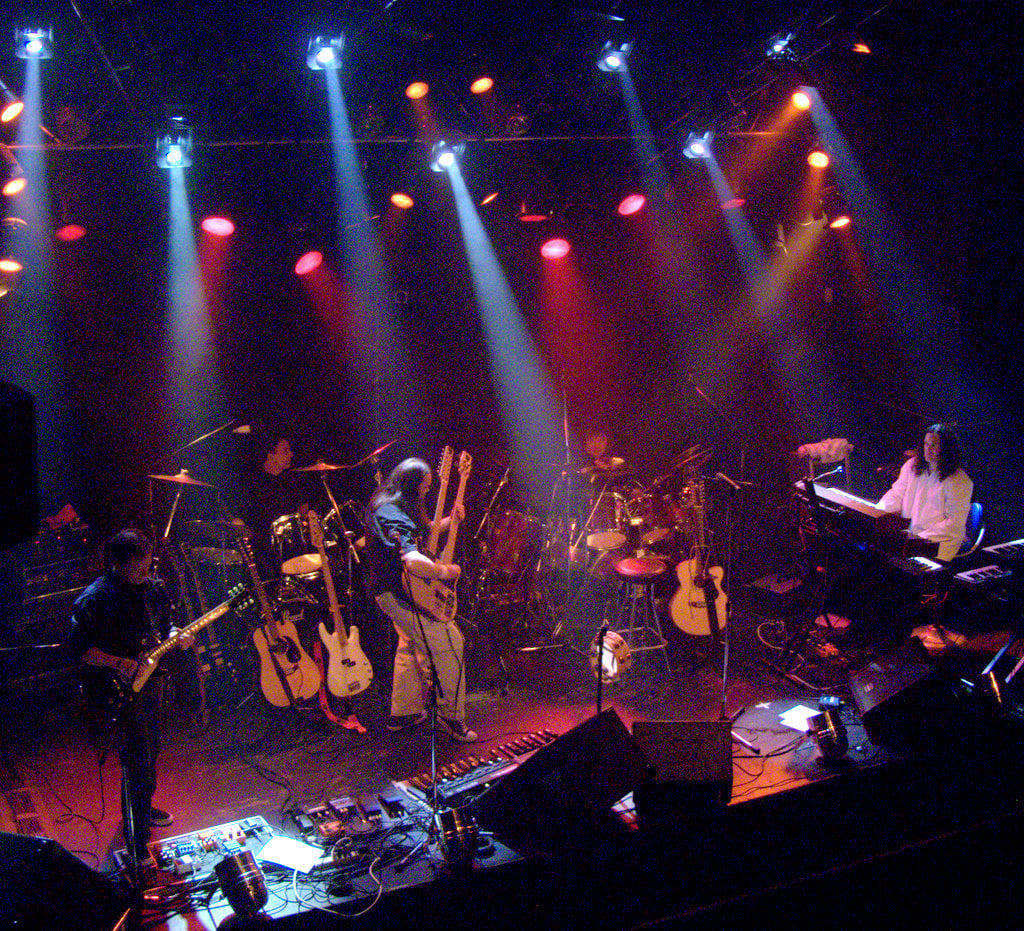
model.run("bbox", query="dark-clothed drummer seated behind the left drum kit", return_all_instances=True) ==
[243,430,309,579]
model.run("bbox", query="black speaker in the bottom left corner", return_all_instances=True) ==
[0,833,128,929]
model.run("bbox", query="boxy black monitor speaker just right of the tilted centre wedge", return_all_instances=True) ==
[633,721,732,824]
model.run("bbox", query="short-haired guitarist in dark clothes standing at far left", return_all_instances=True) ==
[71,530,193,866]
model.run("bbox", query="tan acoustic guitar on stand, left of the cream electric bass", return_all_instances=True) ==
[238,535,321,708]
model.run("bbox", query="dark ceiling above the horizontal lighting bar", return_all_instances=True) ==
[0,0,888,145]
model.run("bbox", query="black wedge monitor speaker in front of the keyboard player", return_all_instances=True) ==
[850,640,955,745]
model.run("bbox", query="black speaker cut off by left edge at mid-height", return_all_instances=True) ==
[0,380,39,550]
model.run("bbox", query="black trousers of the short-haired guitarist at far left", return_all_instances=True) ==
[118,677,163,857]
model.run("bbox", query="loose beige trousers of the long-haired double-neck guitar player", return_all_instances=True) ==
[377,592,466,721]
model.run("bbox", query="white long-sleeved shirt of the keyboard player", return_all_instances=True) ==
[879,456,974,559]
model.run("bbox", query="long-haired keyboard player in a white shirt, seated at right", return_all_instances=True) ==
[878,423,974,560]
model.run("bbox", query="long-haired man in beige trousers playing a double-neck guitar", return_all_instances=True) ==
[366,459,477,744]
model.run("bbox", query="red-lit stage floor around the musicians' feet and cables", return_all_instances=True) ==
[5,604,1007,929]
